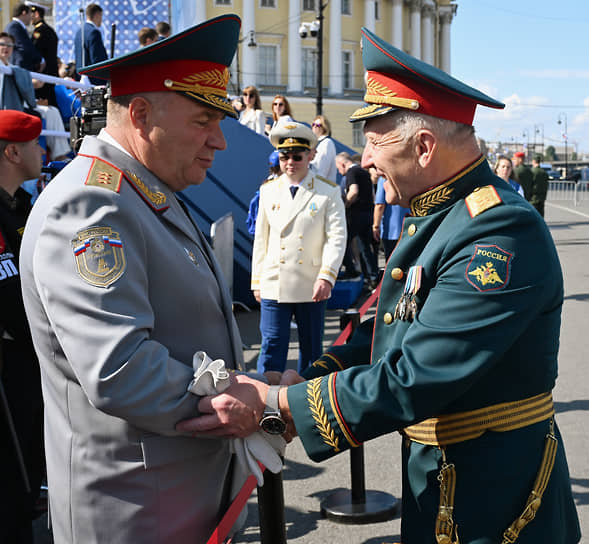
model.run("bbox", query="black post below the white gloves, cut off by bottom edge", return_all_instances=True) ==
[258,470,286,544]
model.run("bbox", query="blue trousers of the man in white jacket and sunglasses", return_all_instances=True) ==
[258,298,327,374]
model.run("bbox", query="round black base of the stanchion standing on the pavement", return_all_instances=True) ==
[321,489,399,525]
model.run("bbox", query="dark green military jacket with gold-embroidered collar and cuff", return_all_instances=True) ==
[288,158,579,544]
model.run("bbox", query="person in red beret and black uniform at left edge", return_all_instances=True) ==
[0,110,44,544]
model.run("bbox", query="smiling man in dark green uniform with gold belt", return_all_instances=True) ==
[178,29,580,544]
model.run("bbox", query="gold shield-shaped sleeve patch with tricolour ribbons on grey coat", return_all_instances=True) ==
[72,227,127,287]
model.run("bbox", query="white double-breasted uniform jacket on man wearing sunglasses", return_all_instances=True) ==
[251,170,346,303]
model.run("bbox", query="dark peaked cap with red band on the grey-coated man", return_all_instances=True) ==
[78,14,241,117]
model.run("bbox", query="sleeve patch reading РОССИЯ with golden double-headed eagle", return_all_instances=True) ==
[465,244,513,291]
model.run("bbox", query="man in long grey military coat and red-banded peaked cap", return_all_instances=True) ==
[21,15,242,544]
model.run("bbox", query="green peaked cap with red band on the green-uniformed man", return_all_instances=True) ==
[350,28,505,125]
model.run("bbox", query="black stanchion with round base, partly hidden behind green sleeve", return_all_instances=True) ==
[321,310,399,525]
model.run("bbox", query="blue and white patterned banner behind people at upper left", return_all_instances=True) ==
[53,0,169,62]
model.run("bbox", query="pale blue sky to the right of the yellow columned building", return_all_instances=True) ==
[451,0,589,157]
